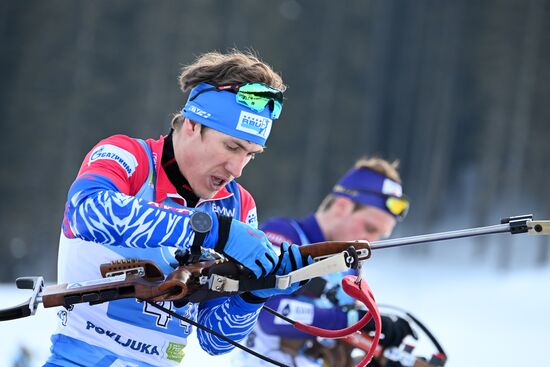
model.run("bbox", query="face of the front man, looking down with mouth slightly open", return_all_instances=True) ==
[174,119,263,199]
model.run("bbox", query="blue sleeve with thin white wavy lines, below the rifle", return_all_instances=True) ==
[197,296,263,355]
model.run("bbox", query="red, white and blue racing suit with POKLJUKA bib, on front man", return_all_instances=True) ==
[44,135,262,366]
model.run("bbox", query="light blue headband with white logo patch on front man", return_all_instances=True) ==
[181,83,272,146]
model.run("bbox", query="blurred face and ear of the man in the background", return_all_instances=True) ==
[326,198,396,241]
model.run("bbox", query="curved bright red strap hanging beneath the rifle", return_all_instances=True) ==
[294,275,382,367]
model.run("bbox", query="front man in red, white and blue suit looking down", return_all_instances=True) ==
[46,51,311,367]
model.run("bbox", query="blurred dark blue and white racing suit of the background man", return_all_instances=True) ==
[233,214,356,367]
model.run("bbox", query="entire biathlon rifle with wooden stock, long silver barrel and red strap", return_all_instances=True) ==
[0,215,550,366]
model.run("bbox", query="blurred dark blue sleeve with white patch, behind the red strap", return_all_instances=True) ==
[259,296,348,339]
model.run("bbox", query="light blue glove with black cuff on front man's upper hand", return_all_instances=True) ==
[215,216,278,278]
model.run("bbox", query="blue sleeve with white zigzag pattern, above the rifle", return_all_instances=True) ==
[63,175,217,248]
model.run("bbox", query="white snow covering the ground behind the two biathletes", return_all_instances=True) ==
[0,254,550,367]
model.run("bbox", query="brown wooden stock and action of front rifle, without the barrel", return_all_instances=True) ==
[0,241,370,321]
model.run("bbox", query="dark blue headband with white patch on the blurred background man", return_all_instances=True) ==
[331,167,403,216]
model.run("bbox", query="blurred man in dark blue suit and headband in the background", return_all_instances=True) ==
[233,158,413,367]
